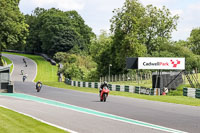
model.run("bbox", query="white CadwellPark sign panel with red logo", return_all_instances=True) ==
[138,57,185,70]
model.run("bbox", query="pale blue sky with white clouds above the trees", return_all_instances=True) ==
[19,0,200,41]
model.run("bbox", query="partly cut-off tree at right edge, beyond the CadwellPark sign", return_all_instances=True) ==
[188,28,200,55]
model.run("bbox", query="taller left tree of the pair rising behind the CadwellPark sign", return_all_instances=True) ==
[111,0,146,73]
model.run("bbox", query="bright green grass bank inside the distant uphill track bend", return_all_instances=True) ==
[4,52,58,82]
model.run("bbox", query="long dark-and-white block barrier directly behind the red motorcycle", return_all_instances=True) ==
[65,79,161,95]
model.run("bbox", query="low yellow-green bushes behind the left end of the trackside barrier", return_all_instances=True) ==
[54,52,98,81]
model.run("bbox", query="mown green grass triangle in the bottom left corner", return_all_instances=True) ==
[0,107,66,133]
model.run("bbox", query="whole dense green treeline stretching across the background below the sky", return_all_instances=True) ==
[0,0,200,81]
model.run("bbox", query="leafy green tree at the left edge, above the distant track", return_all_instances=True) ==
[0,0,28,64]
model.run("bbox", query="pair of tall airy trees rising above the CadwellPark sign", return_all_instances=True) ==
[111,0,178,73]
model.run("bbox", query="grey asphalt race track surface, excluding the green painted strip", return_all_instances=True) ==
[0,55,200,133]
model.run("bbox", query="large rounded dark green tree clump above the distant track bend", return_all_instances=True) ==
[26,8,94,56]
